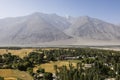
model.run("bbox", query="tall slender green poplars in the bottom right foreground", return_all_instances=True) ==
[54,61,120,80]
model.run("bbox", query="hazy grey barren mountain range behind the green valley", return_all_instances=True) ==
[0,12,120,45]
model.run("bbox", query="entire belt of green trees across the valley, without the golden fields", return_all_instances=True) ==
[0,48,120,80]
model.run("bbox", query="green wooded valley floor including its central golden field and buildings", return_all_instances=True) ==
[0,48,120,80]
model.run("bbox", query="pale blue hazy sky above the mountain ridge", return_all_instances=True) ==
[0,0,120,23]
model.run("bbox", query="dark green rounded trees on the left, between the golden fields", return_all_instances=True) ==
[0,52,53,80]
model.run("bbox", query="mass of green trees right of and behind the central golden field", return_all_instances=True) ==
[41,48,120,80]
